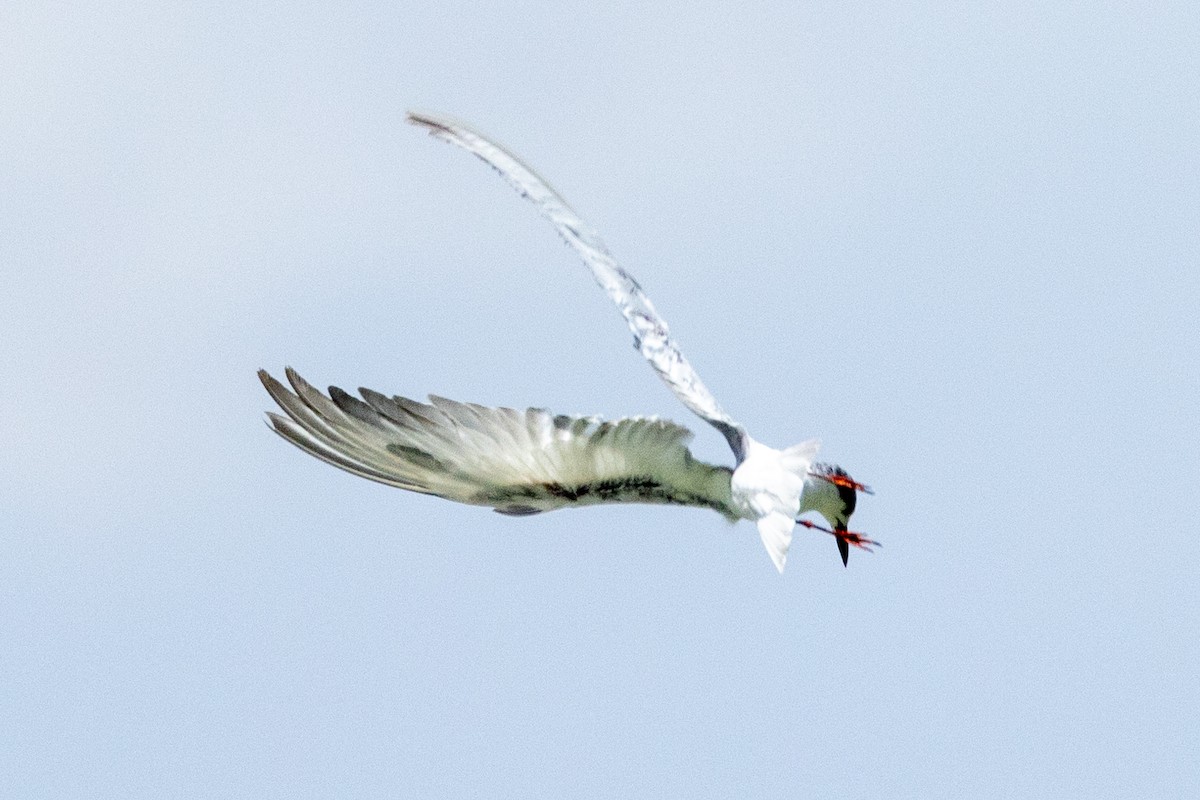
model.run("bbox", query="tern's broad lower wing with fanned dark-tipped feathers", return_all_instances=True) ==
[258,368,737,518]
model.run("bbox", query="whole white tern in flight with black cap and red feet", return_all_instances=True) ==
[258,113,878,572]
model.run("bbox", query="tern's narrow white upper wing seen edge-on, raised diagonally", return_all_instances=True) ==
[408,112,748,463]
